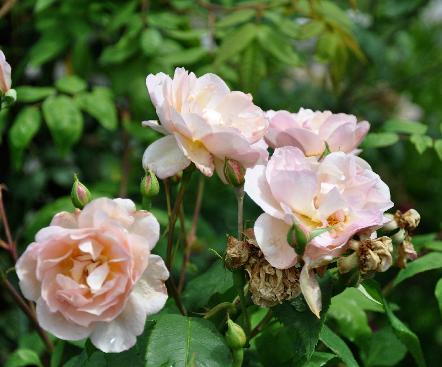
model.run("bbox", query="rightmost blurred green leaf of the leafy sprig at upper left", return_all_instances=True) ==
[75,87,118,131]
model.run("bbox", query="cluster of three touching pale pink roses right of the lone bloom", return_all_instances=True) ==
[143,69,393,317]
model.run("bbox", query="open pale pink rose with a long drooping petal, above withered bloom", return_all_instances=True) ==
[245,147,393,317]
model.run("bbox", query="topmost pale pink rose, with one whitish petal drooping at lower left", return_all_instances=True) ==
[143,68,268,178]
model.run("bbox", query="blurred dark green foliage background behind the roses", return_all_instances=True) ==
[0,0,442,366]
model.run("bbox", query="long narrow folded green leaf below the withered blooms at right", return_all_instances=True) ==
[363,280,426,367]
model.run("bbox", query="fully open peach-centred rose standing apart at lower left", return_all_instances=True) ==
[16,198,169,353]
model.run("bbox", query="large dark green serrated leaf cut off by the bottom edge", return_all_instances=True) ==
[146,314,232,367]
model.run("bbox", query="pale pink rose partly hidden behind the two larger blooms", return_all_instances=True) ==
[265,108,370,156]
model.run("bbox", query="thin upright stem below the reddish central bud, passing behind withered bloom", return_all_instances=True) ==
[233,185,250,337]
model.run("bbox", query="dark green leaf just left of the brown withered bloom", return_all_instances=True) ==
[183,260,233,310]
